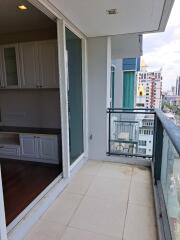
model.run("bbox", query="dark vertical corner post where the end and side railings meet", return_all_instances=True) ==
[153,115,163,184]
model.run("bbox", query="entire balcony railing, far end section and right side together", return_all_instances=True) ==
[107,108,180,240]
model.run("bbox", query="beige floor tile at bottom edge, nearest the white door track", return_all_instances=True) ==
[24,220,66,240]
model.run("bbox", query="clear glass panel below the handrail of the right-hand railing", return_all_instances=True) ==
[161,131,180,240]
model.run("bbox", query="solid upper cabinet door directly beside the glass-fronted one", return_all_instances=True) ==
[19,42,40,88]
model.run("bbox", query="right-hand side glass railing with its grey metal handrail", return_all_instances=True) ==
[153,110,180,240]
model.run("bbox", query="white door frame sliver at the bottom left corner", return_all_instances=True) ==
[0,166,7,240]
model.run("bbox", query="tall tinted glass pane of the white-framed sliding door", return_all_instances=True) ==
[66,28,84,164]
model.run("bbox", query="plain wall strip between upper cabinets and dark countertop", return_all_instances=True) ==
[0,90,60,128]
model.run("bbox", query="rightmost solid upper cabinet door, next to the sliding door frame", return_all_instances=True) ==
[37,40,59,88]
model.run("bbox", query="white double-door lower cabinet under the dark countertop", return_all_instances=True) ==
[20,134,59,164]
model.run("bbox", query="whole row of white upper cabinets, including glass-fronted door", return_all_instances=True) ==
[0,40,59,89]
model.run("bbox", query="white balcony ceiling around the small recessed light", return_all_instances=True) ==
[49,0,174,37]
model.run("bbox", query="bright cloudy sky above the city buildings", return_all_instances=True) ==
[143,0,180,90]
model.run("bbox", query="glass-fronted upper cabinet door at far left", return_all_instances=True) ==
[3,44,21,88]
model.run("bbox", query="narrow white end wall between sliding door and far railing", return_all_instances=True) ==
[87,37,111,160]
